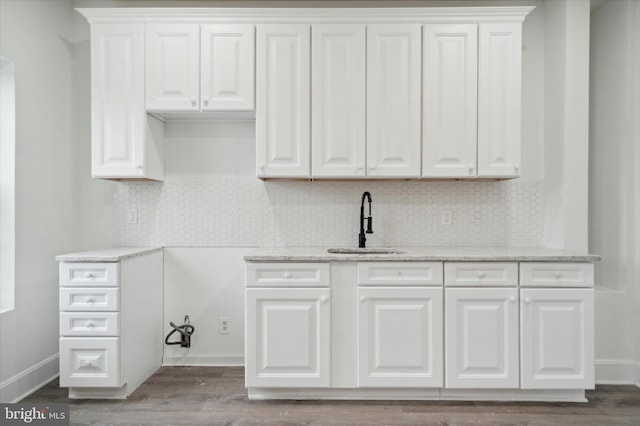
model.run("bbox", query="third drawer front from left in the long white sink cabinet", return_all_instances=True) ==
[444,262,518,287]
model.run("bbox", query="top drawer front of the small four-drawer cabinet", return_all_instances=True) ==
[60,262,119,287]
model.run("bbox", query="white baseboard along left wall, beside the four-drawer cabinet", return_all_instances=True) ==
[0,354,59,403]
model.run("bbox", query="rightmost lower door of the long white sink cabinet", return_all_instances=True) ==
[520,289,594,389]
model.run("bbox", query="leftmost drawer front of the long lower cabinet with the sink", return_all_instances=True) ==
[247,263,331,287]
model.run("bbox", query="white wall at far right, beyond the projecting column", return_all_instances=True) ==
[589,0,640,384]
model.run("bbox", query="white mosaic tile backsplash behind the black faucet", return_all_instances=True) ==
[114,175,544,247]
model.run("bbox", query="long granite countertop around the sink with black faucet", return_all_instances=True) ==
[244,247,600,262]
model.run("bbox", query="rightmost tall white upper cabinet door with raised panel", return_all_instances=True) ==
[478,23,522,177]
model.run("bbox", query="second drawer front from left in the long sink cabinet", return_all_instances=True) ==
[358,262,442,285]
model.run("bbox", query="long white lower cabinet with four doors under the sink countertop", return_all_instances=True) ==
[248,261,594,401]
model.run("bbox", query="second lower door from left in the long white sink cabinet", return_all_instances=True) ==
[358,287,443,387]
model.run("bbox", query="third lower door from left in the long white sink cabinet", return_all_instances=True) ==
[445,288,520,389]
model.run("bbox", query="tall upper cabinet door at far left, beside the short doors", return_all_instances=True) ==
[91,24,146,177]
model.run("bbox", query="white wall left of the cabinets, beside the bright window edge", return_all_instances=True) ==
[0,0,112,402]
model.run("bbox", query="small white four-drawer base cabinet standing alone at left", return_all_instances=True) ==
[59,251,163,399]
